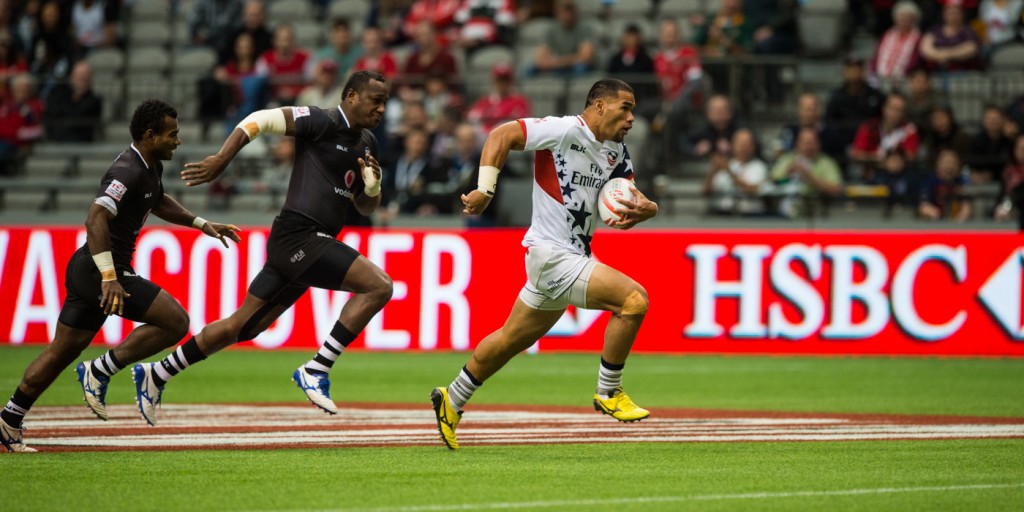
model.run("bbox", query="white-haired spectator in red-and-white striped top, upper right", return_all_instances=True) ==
[868,0,921,89]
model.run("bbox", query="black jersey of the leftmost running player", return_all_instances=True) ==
[92,144,164,265]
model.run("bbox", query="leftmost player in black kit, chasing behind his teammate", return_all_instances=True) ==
[0,99,240,452]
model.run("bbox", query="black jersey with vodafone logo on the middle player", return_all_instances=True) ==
[282,106,380,237]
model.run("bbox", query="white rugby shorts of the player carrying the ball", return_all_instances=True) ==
[519,246,597,311]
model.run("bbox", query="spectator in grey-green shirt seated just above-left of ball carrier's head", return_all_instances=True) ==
[527,0,597,77]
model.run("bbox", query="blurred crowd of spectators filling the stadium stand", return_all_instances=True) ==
[0,0,1024,224]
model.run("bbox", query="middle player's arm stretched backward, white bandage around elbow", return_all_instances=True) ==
[181,106,295,186]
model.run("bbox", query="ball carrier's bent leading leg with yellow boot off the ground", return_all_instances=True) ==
[587,263,650,422]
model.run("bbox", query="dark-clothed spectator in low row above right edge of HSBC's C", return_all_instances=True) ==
[918,150,971,222]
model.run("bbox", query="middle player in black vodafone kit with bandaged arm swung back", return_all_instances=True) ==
[135,71,392,423]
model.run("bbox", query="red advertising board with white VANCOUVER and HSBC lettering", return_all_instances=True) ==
[0,227,1024,356]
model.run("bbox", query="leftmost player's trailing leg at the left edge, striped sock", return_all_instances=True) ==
[0,322,99,452]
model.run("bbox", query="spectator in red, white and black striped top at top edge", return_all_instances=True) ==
[455,0,516,55]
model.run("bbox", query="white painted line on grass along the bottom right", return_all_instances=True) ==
[288,483,1024,512]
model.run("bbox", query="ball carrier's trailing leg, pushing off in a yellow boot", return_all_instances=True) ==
[430,298,564,450]
